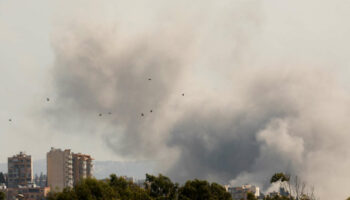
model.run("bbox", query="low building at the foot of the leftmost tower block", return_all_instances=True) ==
[6,184,50,200]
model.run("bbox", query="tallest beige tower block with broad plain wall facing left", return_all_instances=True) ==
[47,148,73,191]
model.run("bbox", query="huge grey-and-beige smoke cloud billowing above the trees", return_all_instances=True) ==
[47,1,350,199]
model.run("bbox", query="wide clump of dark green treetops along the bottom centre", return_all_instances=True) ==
[48,174,232,200]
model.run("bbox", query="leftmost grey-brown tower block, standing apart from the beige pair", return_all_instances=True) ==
[7,152,33,188]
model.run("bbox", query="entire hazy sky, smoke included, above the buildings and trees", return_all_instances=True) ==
[0,0,350,199]
